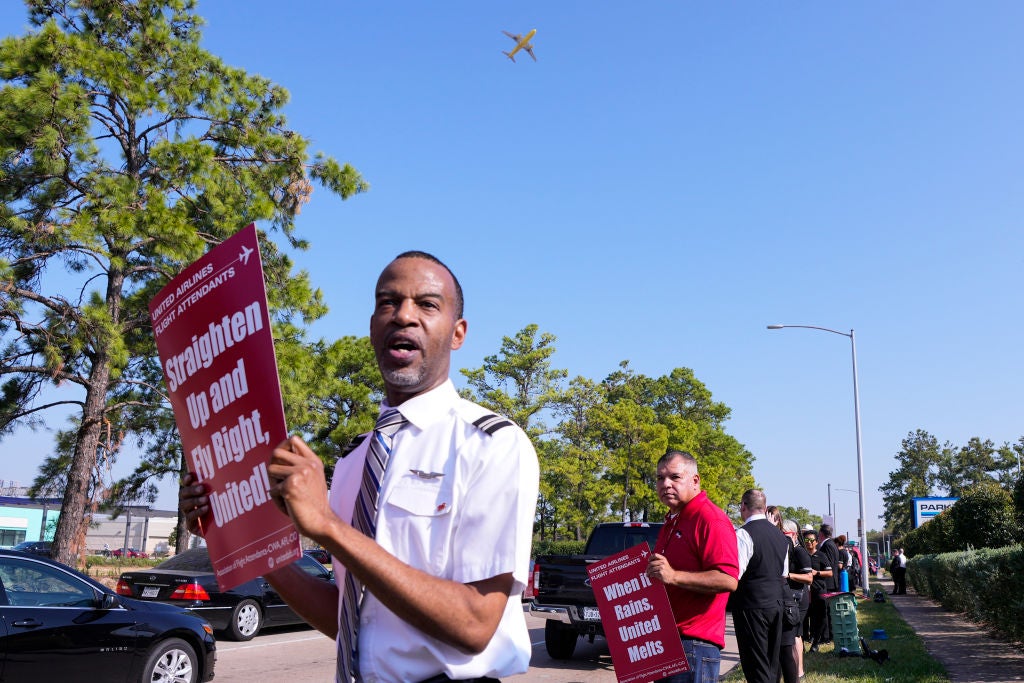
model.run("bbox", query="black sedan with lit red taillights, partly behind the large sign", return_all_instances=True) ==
[118,548,334,640]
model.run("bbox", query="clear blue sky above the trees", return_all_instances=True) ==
[0,0,1024,532]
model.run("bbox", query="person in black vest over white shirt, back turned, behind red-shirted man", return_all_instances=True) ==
[729,488,791,683]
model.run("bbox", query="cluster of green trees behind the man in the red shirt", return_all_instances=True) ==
[463,325,754,540]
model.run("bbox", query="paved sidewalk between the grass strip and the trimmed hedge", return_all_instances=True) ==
[874,578,1024,683]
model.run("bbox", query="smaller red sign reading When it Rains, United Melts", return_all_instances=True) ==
[587,543,690,683]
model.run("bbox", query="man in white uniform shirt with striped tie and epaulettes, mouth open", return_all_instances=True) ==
[179,252,539,683]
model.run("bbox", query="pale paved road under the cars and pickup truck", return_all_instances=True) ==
[215,614,738,683]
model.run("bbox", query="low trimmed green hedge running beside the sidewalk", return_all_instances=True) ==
[906,544,1024,642]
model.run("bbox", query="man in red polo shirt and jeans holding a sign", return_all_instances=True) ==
[647,451,739,683]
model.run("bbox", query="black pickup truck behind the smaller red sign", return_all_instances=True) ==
[529,522,662,659]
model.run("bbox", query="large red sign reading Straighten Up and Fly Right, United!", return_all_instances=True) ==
[150,225,302,590]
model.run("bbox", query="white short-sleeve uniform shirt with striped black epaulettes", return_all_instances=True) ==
[331,380,540,683]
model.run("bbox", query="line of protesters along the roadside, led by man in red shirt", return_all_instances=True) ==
[647,466,872,683]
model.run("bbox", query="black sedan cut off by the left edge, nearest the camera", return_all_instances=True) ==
[0,550,216,683]
